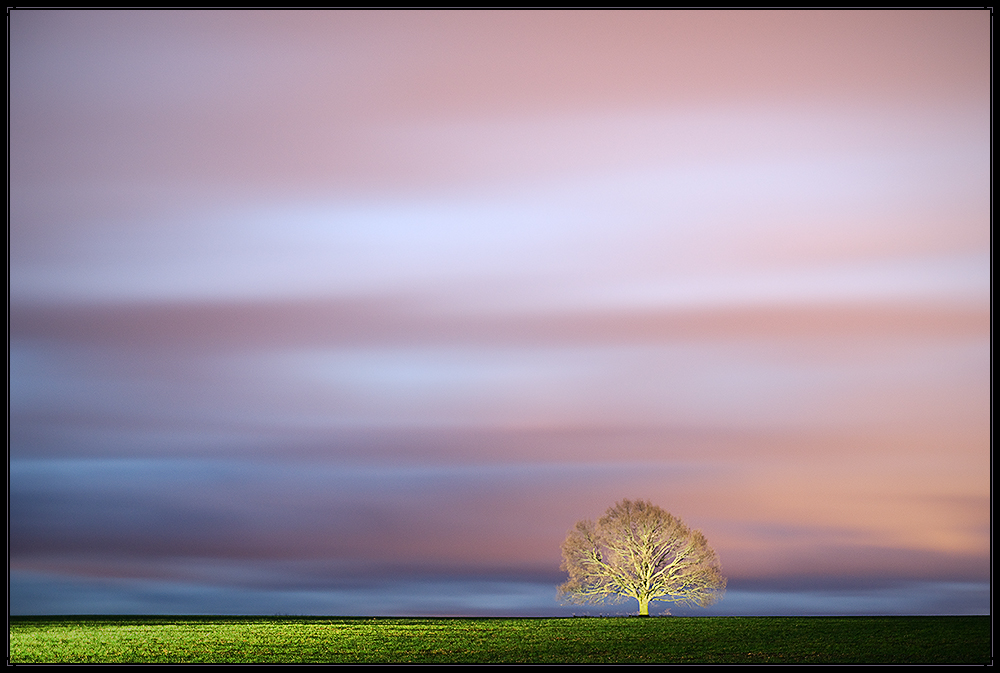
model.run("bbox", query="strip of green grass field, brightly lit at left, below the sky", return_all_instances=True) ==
[10,616,992,664]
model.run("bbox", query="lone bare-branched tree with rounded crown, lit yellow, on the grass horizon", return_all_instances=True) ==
[559,500,726,616]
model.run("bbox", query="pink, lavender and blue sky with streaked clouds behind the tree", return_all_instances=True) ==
[8,9,991,616]
